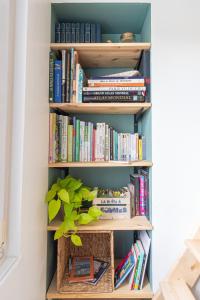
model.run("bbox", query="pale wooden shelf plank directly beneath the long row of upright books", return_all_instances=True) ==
[49,160,152,168]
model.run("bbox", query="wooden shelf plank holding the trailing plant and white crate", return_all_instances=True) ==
[47,216,153,231]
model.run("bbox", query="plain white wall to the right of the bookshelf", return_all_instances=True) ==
[152,0,200,287]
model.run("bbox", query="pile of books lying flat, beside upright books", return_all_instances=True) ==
[83,70,146,103]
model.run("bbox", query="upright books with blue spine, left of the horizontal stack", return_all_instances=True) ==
[49,48,86,103]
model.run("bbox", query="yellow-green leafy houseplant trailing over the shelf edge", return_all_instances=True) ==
[45,175,102,246]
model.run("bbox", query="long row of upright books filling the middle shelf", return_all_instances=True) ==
[49,113,146,163]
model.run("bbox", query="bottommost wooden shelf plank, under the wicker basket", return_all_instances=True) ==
[47,275,153,299]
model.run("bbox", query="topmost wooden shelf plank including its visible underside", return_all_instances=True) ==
[50,43,151,68]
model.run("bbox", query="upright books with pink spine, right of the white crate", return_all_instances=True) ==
[128,169,149,217]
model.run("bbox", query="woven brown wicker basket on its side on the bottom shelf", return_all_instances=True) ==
[57,231,114,293]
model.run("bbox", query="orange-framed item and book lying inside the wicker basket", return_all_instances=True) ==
[67,256,109,285]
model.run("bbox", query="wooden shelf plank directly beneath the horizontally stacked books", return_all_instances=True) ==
[49,103,151,115]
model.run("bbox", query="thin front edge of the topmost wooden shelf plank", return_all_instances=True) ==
[50,43,151,51]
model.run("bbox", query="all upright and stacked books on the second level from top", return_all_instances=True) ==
[49,48,146,103]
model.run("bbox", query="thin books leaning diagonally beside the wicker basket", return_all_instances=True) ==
[115,231,151,290]
